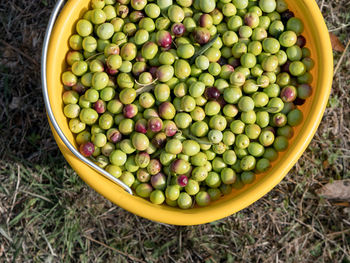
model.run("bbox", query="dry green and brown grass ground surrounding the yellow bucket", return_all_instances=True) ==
[0,0,350,263]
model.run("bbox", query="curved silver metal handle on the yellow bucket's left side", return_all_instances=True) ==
[41,0,133,195]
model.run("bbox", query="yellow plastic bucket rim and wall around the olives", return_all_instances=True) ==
[43,0,333,225]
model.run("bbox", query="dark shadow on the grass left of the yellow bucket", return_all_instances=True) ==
[0,0,65,165]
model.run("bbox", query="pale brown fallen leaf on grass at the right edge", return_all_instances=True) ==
[316,180,350,201]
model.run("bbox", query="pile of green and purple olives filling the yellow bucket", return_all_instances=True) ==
[62,0,314,209]
